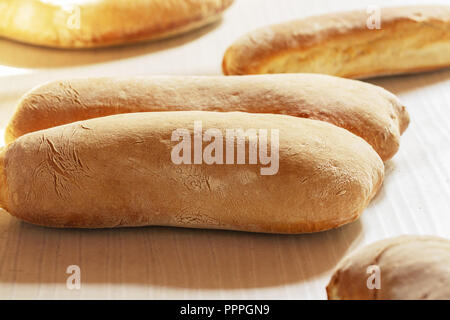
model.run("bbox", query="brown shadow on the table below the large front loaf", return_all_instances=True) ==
[0,211,362,289]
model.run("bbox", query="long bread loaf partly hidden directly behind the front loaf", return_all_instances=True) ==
[6,74,409,160]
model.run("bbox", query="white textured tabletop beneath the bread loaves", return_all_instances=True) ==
[0,0,450,299]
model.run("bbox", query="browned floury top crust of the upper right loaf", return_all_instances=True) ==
[223,6,450,74]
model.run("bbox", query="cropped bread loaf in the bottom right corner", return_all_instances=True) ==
[327,236,450,300]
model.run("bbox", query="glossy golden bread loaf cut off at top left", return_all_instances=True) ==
[0,0,233,48]
